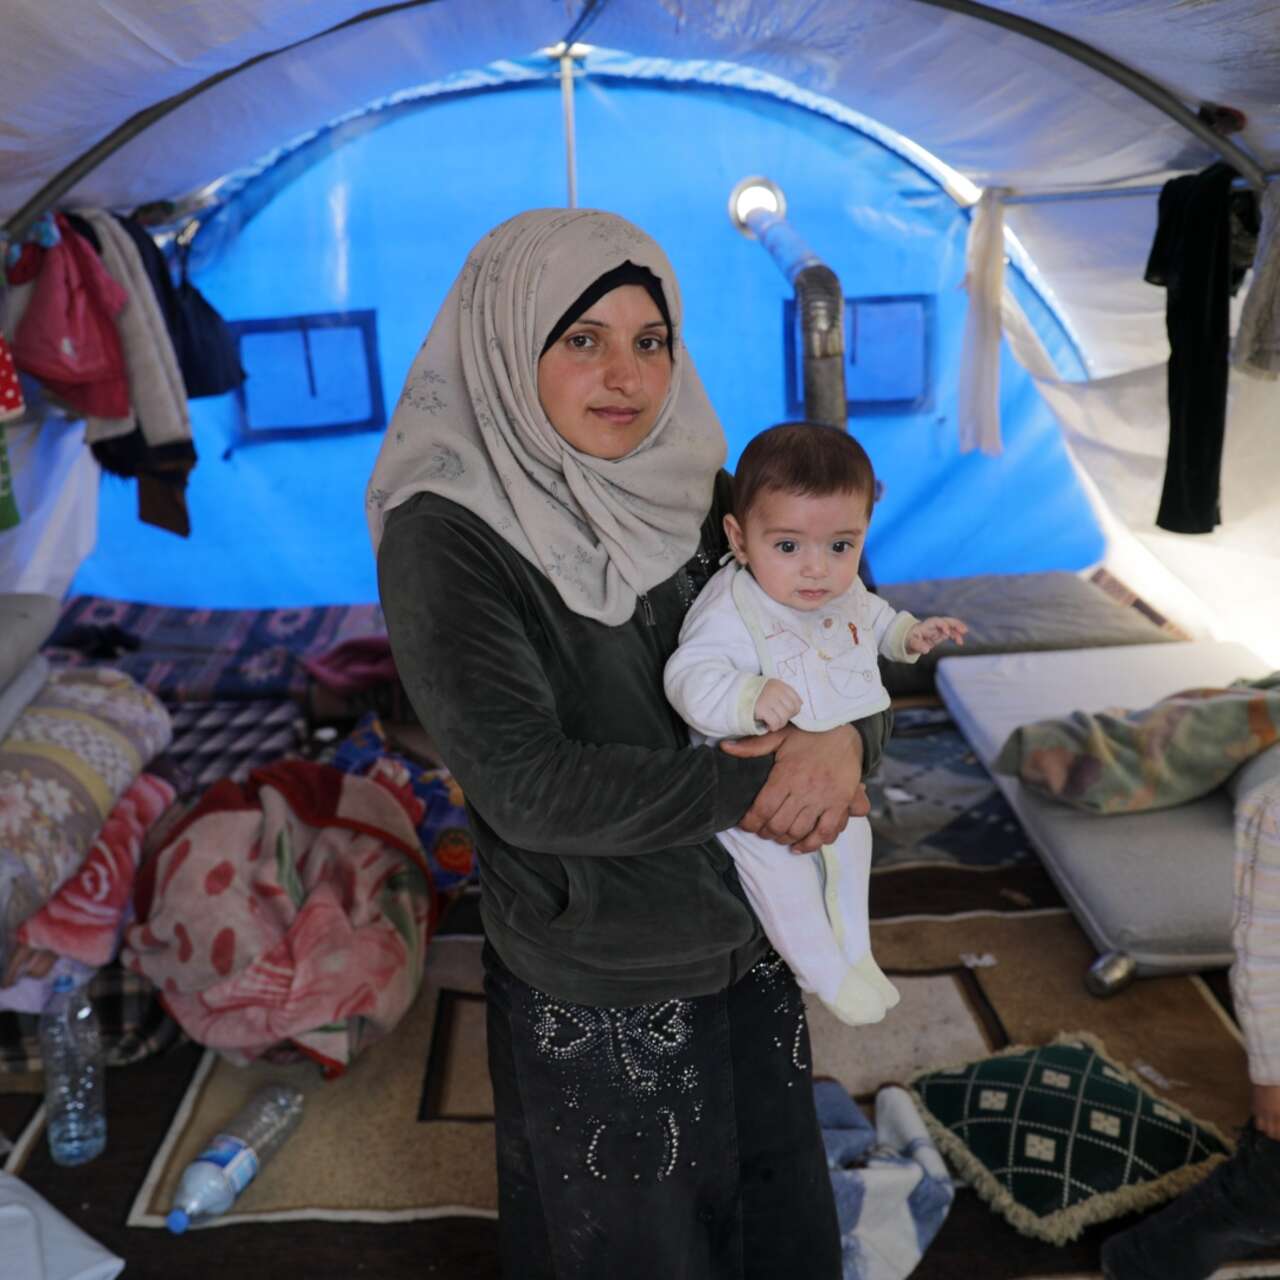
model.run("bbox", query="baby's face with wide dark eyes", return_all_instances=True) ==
[724,490,868,611]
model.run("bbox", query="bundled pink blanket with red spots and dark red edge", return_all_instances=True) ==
[122,759,435,1075]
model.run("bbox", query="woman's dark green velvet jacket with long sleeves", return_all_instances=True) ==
[378,472,890,1005]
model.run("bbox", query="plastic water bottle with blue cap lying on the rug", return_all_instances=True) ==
[165,1084,302,1235]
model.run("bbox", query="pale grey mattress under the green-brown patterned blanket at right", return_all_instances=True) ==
[938,640,1268,974]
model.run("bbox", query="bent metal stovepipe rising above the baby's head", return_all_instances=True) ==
[742,209,849,431]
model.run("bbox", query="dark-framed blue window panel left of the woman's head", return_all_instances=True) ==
[230,311,387,444]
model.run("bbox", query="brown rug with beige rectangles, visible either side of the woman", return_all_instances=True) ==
[129,909,1248,1254]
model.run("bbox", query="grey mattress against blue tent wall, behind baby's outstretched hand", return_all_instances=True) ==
[876,570,1178,696]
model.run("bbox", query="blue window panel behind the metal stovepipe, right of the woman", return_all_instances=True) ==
[782,293,934,417]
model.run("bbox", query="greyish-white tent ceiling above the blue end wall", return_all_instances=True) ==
[0,0,1280,225]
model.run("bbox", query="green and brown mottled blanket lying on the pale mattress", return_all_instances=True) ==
[995,672,1280,813]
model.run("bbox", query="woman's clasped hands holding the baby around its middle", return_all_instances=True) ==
[721,724,870,854]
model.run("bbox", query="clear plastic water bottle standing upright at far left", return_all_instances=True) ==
[40,974,106,1165]
